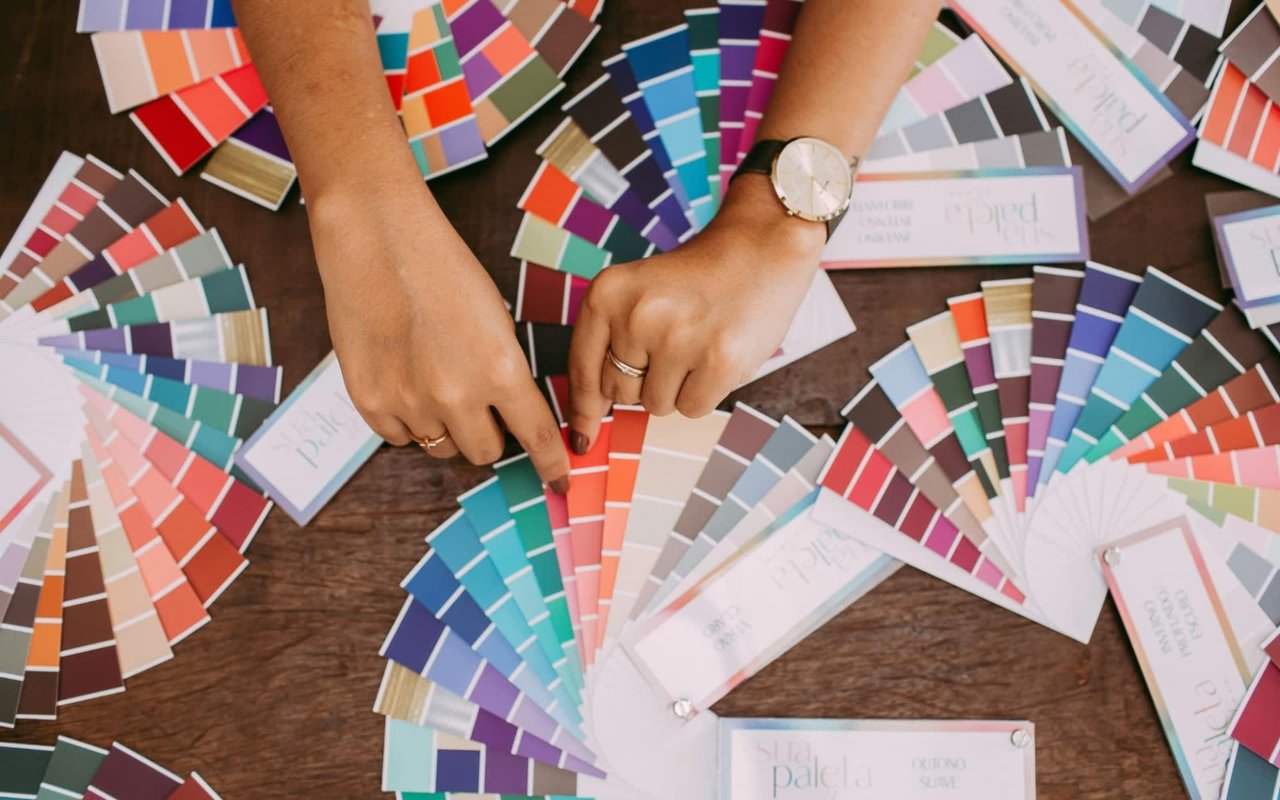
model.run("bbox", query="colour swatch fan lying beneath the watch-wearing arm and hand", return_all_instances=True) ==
[511,7,1088,391]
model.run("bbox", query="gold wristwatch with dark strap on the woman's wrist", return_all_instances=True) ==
[733,136,859,241]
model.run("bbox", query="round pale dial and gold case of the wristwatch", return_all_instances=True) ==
[773,137,854,221]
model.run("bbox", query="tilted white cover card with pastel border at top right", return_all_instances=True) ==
[951,0,1196,193]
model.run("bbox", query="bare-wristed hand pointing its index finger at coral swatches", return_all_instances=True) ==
[307,173,568,493]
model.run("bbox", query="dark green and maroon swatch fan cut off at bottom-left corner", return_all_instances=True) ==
[0,736,219,800]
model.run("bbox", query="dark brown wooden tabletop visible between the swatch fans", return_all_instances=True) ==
[0,0,1231,800]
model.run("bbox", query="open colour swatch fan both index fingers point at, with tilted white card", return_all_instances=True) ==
[375,404,899,799]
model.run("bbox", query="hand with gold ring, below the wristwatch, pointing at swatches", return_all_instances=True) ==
[570,177,826,453]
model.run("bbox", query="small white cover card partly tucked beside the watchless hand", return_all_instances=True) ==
[236,353,381,524]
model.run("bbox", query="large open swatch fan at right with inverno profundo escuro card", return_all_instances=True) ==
[814,262,1280,797]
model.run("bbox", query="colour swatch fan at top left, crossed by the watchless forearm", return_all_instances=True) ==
[77,0,603,209]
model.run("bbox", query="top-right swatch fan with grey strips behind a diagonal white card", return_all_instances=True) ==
[950,0,1213,218]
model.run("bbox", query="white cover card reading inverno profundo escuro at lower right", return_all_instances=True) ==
[1100,518,1249,799]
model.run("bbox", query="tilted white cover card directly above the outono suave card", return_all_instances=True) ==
[631,504,896,709]
